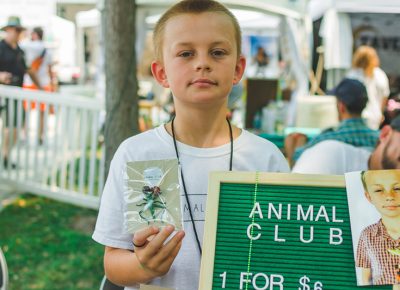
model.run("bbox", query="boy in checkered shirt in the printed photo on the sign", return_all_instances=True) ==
[356,170,400,285]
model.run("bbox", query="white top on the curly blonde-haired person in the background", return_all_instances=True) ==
[347,67,390,130]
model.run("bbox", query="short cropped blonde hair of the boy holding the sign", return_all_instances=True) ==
[153,0,242,61]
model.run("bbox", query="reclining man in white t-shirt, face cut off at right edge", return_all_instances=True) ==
[292,115,400,175]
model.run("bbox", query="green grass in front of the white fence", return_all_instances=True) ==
[0,194,103,290]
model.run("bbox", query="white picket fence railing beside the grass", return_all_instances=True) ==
[0,85,104,209]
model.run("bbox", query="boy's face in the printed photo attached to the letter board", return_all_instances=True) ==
[365,170,400,218]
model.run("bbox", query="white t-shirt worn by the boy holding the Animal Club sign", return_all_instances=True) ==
[93,125,289,290]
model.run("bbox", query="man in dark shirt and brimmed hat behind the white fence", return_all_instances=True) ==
[0,16,42,166]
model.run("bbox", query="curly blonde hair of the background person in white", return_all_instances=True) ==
[353,45,379,77]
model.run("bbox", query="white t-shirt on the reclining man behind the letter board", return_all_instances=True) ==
[292,140,371,175]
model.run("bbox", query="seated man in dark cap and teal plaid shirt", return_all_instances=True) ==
[285,78,379,167]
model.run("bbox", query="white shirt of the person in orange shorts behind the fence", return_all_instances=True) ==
[20,41,52,86]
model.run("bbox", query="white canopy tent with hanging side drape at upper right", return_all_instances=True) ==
[309,0,400,87]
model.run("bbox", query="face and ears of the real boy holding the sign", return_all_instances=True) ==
[152,12,245,106]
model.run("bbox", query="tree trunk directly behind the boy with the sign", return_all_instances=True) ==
[102,0,138,177]
